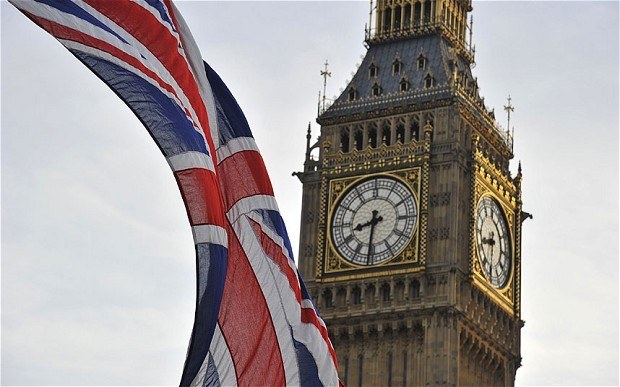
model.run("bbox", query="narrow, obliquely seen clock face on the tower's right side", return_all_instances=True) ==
[476,196,512,289]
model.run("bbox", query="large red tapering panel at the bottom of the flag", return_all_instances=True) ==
[218,228,286,386]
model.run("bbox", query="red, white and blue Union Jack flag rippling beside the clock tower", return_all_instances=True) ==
[11,0,338,386]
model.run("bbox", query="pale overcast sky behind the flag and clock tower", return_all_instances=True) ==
[0,1,619,385]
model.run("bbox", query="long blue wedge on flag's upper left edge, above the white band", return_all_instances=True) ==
[71,50,209,156]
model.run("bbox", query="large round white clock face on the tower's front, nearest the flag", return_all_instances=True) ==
[331,176,418,266]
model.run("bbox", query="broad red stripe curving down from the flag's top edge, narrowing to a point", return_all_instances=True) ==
[85,0,215,155]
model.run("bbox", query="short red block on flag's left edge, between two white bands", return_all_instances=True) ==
[174,168,225,227]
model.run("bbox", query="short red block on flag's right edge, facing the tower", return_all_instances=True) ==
[217,151,273,212]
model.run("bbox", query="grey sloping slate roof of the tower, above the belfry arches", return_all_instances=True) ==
[318,34,474,122]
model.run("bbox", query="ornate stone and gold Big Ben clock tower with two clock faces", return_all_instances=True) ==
[296,0,523,386]
